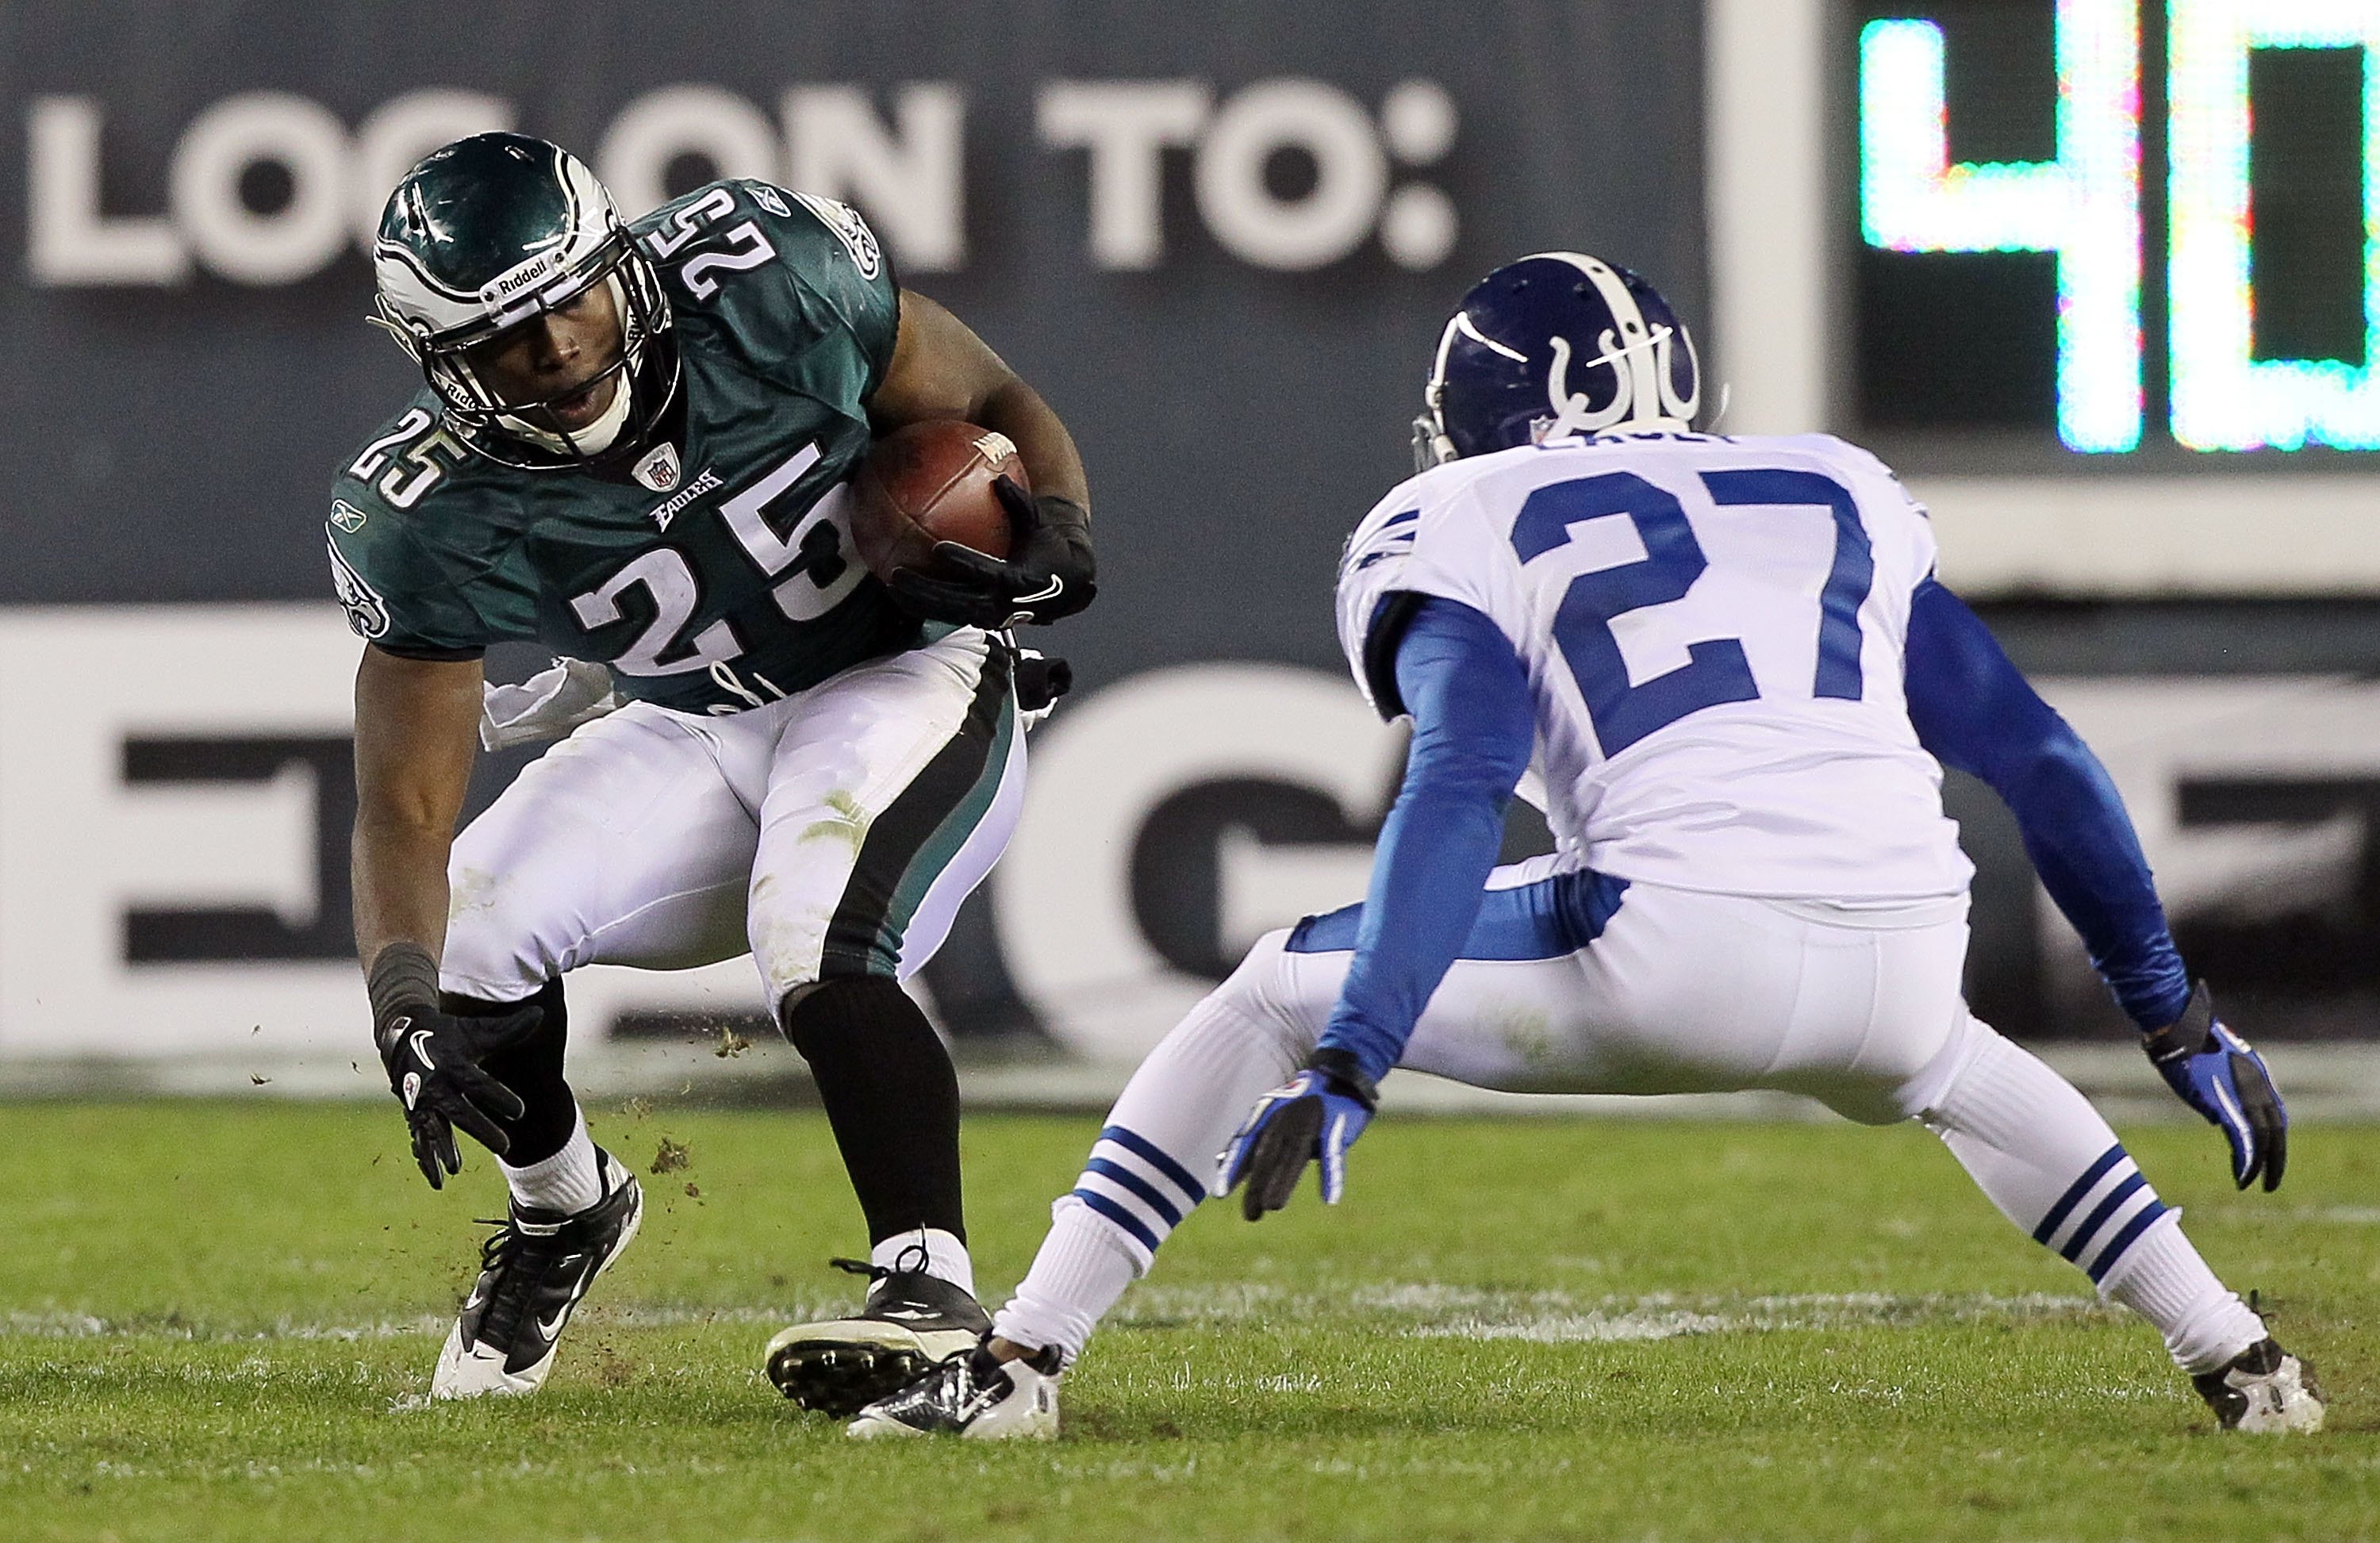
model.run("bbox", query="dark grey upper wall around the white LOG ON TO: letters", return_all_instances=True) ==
[0,0,1704,683]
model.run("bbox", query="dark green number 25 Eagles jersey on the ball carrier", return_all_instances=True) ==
[326,181,923,712]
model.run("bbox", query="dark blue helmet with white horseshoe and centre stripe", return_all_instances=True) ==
[1414,252,1702,471]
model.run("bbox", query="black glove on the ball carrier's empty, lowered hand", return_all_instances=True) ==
[371,943,545,1188]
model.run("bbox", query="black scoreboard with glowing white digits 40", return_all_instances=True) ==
[1837,0,2380,457]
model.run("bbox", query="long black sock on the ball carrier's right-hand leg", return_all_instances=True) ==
[785,977,966,1243]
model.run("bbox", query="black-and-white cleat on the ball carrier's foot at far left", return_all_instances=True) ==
[431,1148,645,1398]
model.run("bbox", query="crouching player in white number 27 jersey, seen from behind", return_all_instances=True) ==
[852,252,2323,1438]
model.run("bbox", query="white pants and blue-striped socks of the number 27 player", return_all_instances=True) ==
[995,858,2263,1372]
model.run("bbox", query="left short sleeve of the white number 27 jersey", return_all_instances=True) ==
[1338,474,1507,719]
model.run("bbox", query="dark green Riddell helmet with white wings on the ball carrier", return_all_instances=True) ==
[371,133,678,469]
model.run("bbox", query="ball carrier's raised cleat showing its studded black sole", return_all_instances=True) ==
[766,1260,992,1419]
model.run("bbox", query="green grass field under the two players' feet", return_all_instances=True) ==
[0,1105,2380,1543]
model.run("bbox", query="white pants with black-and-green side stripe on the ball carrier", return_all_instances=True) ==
[440,628,1026,1012]
